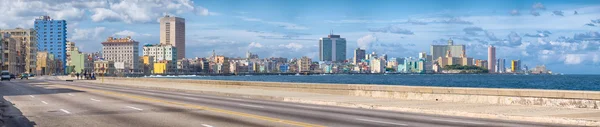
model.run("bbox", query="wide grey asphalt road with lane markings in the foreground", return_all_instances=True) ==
[0,78,562,127]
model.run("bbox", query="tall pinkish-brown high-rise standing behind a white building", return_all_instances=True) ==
[160,15,185,59]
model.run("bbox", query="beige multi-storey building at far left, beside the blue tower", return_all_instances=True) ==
[0,28,37,74]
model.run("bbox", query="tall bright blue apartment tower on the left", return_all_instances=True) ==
[34,16,67,72]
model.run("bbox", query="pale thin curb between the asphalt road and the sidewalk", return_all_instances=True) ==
[76,81,600,126]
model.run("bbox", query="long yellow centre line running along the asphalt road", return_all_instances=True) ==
[56,84,325,127]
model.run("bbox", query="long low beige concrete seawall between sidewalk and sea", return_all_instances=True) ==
[94,77,600,109]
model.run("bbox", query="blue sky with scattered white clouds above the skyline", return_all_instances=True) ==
[0,0,600,74]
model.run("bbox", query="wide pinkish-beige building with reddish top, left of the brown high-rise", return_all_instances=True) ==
[102,36,139,73]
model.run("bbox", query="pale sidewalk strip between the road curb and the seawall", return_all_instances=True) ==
[61,77,600,126]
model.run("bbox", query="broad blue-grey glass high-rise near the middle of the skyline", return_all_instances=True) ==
[319,34,346,62]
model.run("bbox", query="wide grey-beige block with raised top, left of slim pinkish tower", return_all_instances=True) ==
[431,39,465,59]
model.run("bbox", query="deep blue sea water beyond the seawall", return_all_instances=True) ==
[156,74,600,91]
